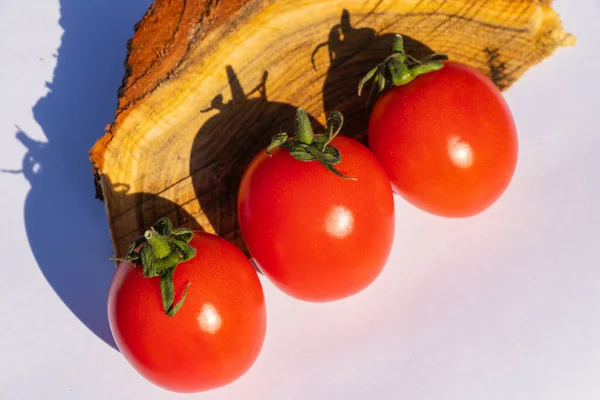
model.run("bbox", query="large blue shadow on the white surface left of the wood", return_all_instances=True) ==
[9,0,151,349]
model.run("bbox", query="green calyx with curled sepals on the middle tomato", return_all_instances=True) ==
[266,108,356,180]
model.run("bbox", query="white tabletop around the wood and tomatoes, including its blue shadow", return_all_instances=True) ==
[0,0,600,400]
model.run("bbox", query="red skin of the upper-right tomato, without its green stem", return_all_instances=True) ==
[368,61,518,217]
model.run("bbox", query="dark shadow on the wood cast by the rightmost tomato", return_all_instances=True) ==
[312,10,434,144]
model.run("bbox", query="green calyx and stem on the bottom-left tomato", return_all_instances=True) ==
[116,217,196,317]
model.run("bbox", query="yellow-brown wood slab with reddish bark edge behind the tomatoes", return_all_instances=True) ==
[91,0,574,256]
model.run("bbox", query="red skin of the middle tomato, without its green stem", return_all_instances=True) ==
[238,136,395,302]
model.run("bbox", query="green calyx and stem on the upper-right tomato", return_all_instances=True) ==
[358,35,448,96]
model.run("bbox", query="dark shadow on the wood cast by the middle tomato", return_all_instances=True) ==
[190,66,323,254]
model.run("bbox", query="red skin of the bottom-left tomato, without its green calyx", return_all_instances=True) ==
[108,232,266,393]
